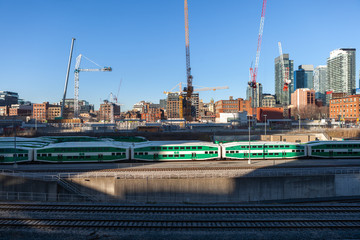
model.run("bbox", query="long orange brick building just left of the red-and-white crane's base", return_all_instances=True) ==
[215,96,254,118]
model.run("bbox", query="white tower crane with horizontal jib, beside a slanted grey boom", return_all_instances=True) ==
[74,54,112,118]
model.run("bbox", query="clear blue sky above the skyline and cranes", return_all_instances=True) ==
[0,0,360,110]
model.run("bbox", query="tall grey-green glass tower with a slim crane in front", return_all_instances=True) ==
[275,54,294,106]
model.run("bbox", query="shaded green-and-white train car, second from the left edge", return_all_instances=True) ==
[34,141,130,163]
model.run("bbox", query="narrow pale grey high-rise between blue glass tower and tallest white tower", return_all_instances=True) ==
[314,65,329,105]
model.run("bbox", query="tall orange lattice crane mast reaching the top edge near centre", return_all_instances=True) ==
[184,0,194,121]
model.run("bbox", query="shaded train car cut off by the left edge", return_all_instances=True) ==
[0,142,33,164]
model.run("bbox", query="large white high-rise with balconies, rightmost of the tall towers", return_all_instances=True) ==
[327,48,356,95]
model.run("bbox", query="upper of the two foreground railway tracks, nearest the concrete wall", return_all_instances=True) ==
[0,204,360,216]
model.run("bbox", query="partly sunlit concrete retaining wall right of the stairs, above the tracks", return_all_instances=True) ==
[72,174,360,203]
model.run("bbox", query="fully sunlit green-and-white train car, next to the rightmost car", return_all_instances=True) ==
[221,142,307,159]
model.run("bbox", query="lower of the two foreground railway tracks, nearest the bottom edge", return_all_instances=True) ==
[0,218,360,230]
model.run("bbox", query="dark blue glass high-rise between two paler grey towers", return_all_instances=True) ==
[294,65,314,91]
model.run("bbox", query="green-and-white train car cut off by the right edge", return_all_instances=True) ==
[307,141,360,158]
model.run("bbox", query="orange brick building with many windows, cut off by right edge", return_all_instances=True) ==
[329,95,360,122]
